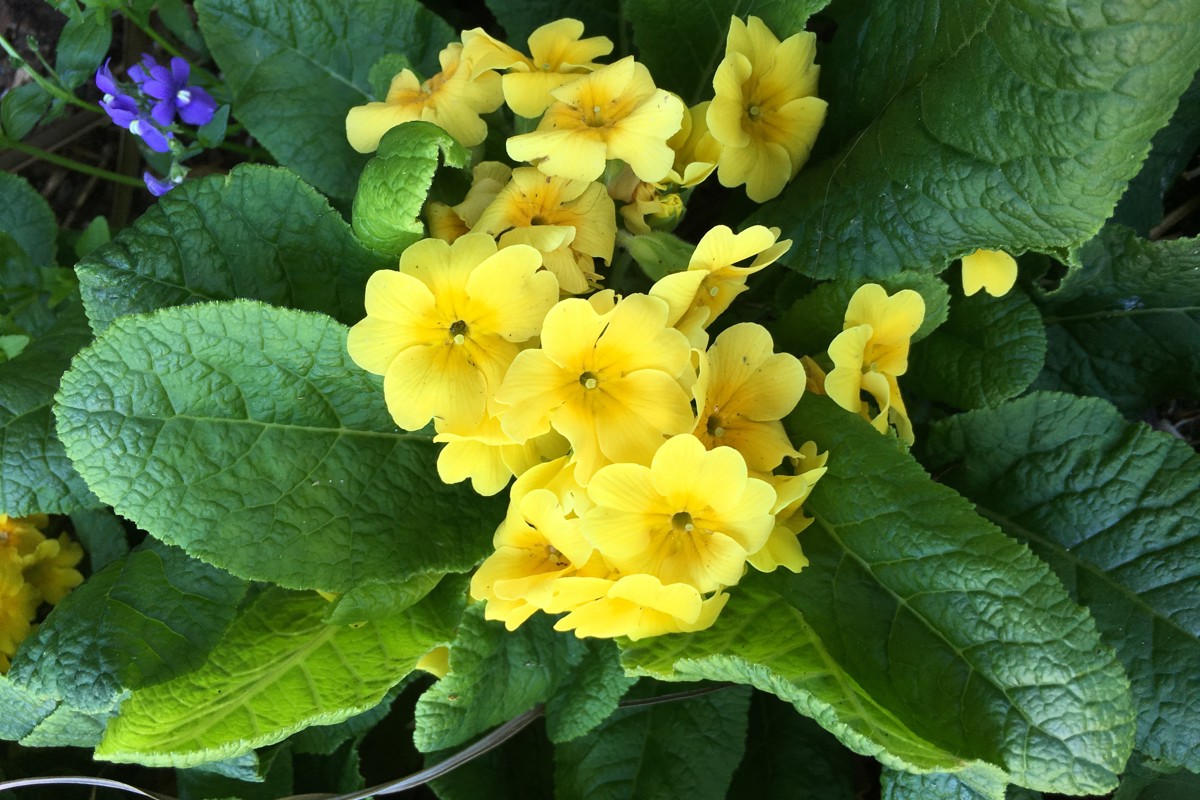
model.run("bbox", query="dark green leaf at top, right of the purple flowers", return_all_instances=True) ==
[196,0,454,198]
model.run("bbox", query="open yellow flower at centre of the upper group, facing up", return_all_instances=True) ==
[508,56,685,181]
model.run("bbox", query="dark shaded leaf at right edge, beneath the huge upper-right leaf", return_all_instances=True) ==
[1036,225,1200,417]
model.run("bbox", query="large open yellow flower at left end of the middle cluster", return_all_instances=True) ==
[347,234,558,438]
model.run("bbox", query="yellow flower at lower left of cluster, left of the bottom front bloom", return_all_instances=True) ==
[470,489,592,631]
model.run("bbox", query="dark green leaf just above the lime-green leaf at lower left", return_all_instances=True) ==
[10,540,246,714]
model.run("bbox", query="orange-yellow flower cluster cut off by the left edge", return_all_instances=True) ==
[0,513,83,673]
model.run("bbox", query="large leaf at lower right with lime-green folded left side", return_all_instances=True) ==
[625,396,1134,794]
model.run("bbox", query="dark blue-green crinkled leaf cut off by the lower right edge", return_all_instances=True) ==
[925,392,1200,771]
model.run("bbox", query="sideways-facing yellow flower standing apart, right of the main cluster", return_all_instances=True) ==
[824,283,925,444]
